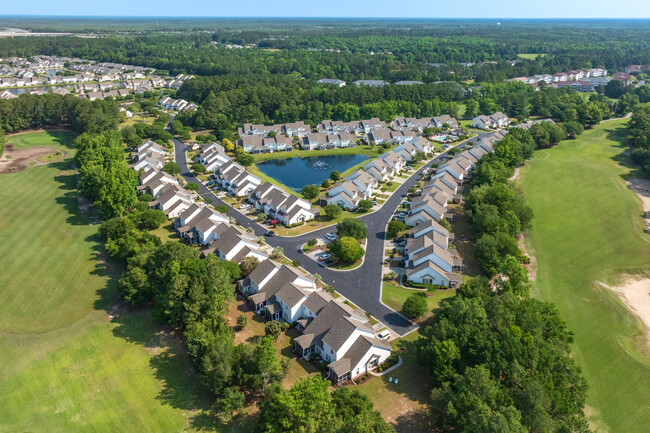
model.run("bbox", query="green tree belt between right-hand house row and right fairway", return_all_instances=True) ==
[416,123,589,433]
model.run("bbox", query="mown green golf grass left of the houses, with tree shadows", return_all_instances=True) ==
[0,133,225,432]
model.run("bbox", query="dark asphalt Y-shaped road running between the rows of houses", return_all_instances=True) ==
[172,133,489,336]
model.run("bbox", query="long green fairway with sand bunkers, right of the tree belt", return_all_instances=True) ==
[521,121,650,432]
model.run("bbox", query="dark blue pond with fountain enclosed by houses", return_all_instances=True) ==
[257,155,368,191]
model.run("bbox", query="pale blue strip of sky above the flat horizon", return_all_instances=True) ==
[0,0,650,18]
